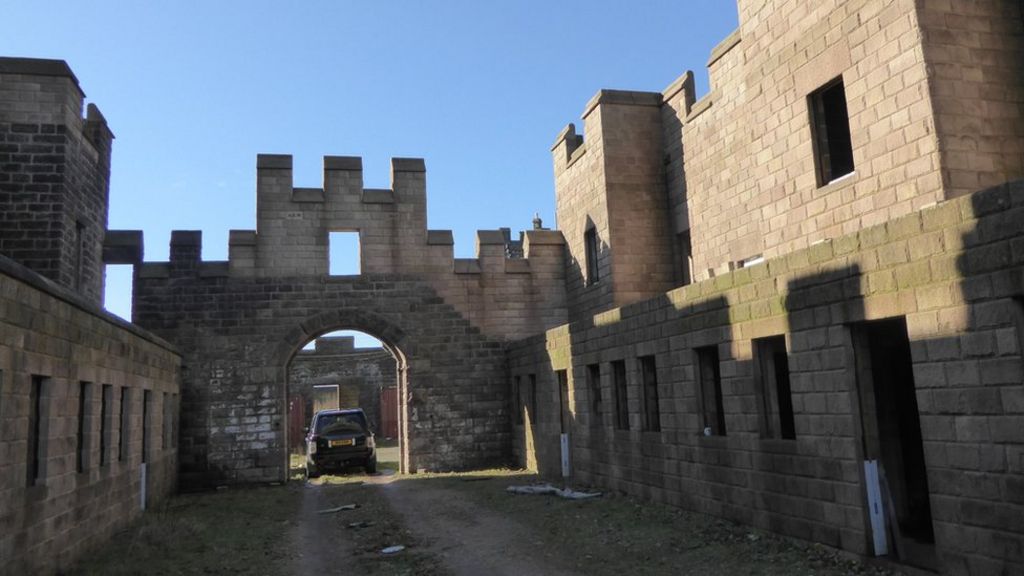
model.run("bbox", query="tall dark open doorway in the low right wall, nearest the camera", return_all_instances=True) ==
[854,317,935,568]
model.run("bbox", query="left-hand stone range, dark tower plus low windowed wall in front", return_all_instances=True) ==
[0,58,181,574]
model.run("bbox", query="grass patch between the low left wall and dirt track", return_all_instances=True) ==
[74,486,301,576]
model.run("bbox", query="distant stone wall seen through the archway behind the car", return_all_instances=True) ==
[288,336,398,432]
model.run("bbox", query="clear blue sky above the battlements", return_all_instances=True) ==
[0,0,736,344]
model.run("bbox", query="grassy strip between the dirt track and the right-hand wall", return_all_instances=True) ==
[404,469,898,576]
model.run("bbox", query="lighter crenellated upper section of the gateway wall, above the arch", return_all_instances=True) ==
[121,155,567,338]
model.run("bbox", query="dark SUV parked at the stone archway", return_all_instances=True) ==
[306,408,377,478]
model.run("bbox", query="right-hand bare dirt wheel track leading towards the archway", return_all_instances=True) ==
[380,481,577,576]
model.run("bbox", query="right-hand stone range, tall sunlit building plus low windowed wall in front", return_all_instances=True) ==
[520,0,1024,574]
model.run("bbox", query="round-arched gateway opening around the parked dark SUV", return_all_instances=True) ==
[286,330,404,478]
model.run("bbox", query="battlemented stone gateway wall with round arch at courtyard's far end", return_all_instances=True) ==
[120,156,566,487]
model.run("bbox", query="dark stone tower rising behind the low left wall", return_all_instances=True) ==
[0,57,114,304]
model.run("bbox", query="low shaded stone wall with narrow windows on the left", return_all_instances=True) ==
[0,257,181,575]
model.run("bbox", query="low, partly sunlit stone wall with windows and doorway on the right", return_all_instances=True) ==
[509,181,1024,574]
